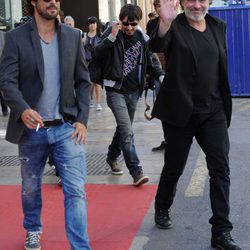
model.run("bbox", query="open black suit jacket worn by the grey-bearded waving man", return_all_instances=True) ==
[149,13,232,127]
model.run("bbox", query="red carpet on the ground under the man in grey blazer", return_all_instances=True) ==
[0,184,156,250]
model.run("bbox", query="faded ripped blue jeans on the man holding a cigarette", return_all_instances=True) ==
[19,123,90,250]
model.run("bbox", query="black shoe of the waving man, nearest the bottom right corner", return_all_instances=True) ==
[211,232,241,250]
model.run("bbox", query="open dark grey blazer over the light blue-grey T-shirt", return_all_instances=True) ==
[0,20,91,143]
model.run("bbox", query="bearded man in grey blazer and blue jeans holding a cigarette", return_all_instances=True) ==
[0,0,91,250]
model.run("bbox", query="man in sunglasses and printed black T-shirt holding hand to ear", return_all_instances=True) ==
[94,4,164,186]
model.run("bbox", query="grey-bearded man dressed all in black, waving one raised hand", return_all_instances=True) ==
[150,0,241,250]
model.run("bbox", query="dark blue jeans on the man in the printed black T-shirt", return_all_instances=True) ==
[107,91,141,176]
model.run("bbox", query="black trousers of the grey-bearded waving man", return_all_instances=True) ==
[155,106,233,235]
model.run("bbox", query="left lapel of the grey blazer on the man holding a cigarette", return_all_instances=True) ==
[30,20,44,82]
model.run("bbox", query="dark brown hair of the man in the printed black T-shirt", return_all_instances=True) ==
[119,4,142,21]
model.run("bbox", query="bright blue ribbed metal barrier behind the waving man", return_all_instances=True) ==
[209,4,250,96]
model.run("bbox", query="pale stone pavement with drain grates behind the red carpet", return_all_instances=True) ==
[0,92,163,184]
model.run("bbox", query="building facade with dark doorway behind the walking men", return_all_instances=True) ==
[0,0,153,31]
